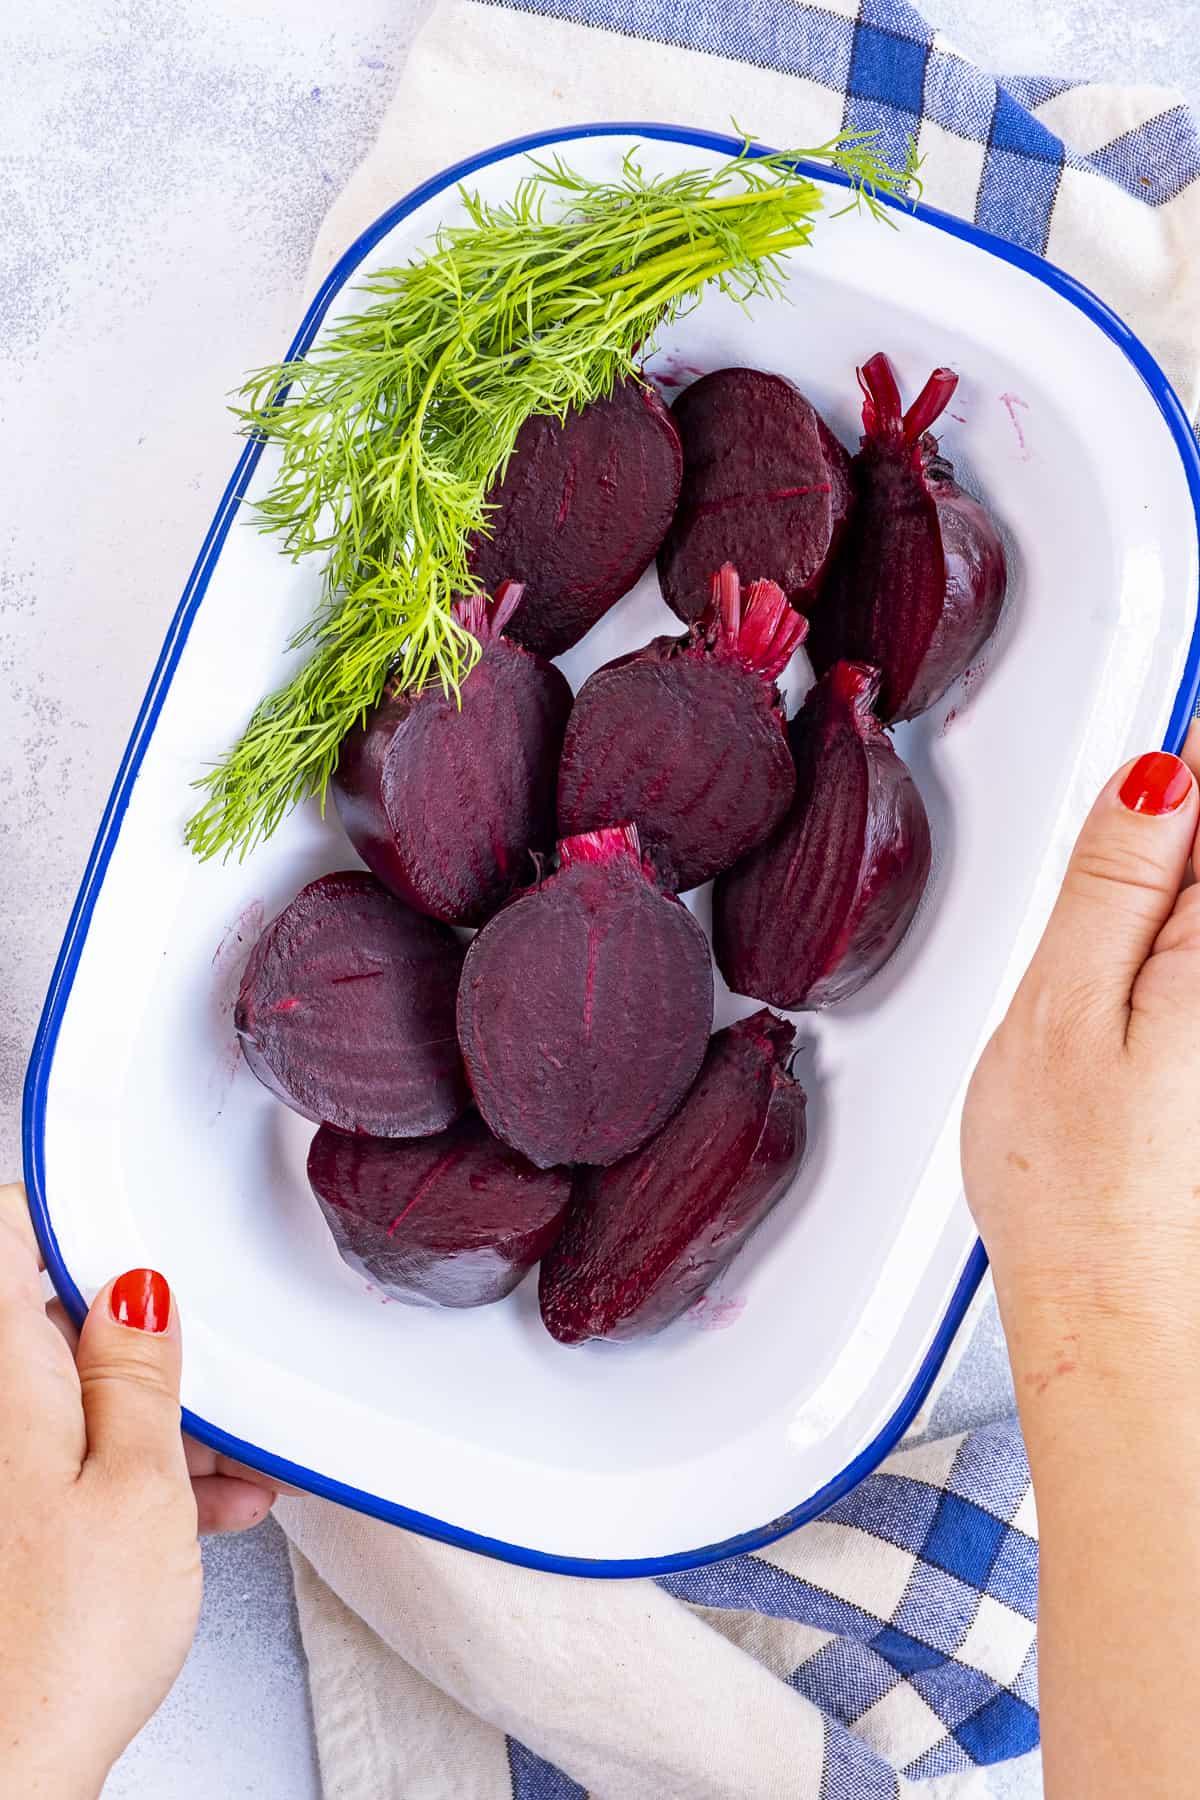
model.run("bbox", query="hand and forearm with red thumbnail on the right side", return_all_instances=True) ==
[963,727,1200,1800]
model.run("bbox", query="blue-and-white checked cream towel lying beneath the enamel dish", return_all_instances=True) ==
[279,0,1200,1800]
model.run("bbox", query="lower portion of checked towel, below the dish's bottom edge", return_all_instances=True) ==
[277,1422,1038,1800]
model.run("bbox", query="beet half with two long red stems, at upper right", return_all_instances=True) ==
[808,353,1007,722]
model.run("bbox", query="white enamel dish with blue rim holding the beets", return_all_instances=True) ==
[25,126,1200,1575]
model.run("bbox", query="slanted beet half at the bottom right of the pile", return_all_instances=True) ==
[538,1010,804,1345]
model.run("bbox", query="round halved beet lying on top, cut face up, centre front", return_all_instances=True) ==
[459,824,712,1168]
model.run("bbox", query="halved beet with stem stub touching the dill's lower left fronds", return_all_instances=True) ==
[333,581,570,925]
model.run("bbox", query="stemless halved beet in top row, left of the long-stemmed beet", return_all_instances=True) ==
[658,369,853,621]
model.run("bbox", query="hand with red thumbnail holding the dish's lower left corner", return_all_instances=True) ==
[0,1186,204,1800]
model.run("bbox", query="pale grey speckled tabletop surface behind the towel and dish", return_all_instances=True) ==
[0,0,1200,1800]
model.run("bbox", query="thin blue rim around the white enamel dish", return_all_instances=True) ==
[22,124,1200,1577]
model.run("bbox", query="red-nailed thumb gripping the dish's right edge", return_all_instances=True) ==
[1025,751,1200,1030]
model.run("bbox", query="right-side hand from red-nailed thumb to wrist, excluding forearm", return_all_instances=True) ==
[963,725,1200,1346]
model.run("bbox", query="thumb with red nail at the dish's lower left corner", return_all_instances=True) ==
[76,1269,187,1481]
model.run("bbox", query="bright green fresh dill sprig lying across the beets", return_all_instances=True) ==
[187,133,916,857]
